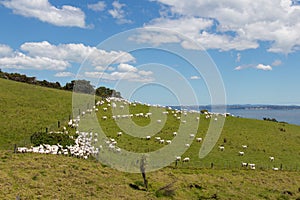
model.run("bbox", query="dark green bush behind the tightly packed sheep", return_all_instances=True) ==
[30,132,75,147]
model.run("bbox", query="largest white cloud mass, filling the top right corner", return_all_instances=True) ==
[150,0,300,54]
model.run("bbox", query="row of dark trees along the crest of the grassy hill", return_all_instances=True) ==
[0,69,121,98]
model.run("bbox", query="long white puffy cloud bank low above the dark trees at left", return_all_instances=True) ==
[0,41,135,70]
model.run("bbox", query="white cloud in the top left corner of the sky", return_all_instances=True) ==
[0,0,86,28]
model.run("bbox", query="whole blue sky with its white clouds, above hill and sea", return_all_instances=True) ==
[0,0,300,105]
